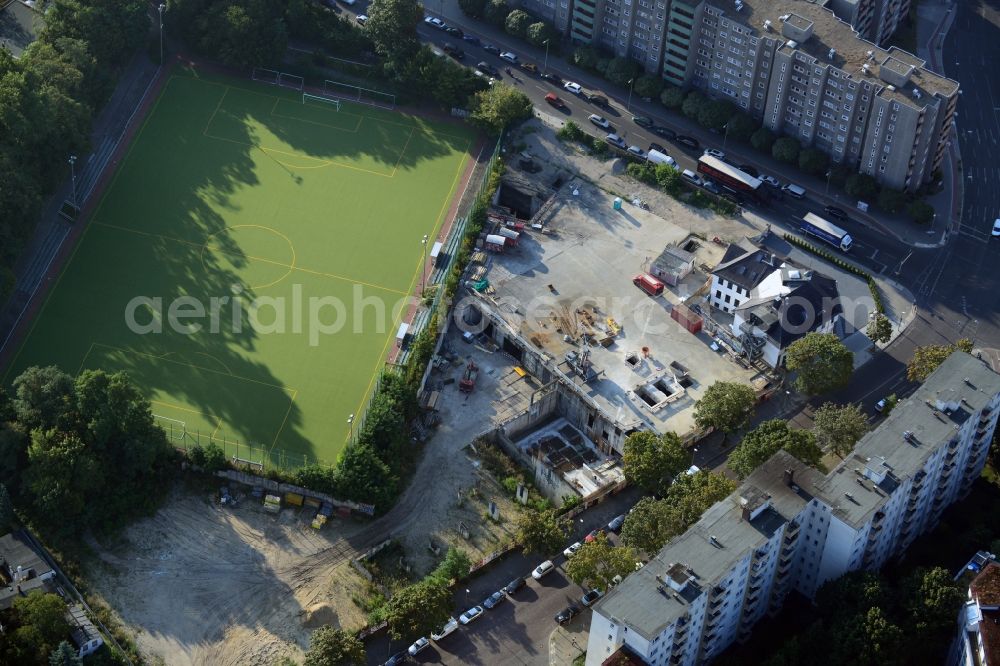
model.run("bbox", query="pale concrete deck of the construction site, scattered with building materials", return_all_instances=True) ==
[482,183,766,434]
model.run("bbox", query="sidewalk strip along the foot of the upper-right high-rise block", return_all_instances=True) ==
[431,0,961,248]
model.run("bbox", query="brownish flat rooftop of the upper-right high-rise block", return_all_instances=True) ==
[708,0,958,103]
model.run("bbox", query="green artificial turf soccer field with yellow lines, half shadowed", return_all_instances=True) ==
[5,70,473,464]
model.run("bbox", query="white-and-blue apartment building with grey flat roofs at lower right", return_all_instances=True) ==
[586,352,1000,666]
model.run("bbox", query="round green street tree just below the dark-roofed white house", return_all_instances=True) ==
[785,332,854,395]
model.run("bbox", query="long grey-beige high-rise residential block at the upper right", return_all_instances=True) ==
[570,0,958,191]
